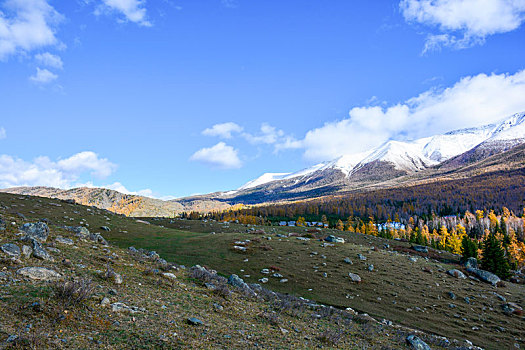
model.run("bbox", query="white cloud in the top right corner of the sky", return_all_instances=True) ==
[399,0,525,51]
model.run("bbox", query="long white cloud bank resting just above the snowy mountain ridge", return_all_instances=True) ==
[276,70,525,161]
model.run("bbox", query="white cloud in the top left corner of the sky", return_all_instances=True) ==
[0,0,63,60]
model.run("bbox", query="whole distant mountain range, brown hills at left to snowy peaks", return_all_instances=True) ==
[4,113,525,216]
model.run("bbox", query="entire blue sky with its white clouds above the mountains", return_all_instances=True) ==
[0,0,525,197]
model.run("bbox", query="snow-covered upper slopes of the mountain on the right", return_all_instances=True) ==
[237,113,525,191]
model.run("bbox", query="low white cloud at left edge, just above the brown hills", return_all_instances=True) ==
[0,152,117,188]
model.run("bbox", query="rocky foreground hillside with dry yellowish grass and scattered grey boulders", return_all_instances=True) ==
[0,194,482,349]
